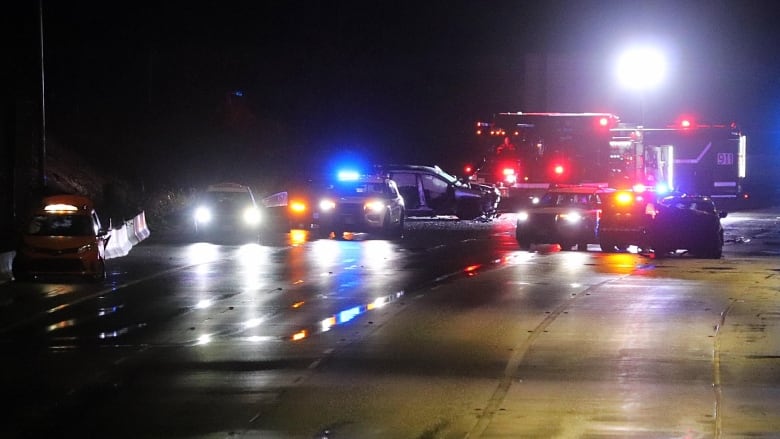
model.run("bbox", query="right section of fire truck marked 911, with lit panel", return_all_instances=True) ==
[610,118,747,201]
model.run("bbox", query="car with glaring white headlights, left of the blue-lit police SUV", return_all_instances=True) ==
[193,182,261,240]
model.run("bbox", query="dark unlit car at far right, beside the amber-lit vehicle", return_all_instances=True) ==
[649,195,727,259]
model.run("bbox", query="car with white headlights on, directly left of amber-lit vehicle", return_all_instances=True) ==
[515,186,610,251]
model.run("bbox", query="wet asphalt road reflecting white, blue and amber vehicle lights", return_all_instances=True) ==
[0,211,780,438]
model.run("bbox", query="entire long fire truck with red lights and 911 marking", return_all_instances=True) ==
[465,112,747,211]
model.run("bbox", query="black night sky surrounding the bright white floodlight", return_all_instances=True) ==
[9,0,780,189]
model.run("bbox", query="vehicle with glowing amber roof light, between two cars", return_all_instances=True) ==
[596,190,655,252]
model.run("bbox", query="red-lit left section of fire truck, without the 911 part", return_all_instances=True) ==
[465,112,619,210]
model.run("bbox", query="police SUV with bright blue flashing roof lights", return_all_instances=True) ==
[315,171,406,239]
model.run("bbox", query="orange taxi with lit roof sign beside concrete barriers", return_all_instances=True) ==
[12,195,110,280]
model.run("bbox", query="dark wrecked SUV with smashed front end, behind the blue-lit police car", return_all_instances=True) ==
[381,165,501,220]
